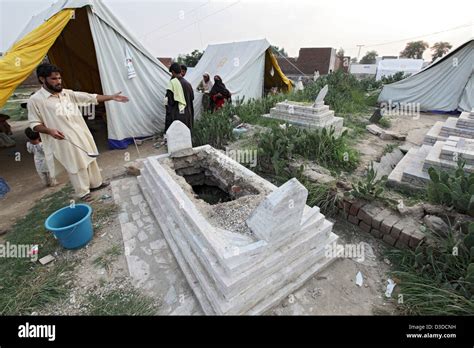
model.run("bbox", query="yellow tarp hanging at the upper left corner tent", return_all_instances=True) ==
[0,10,74,107]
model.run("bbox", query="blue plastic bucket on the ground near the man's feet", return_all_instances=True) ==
[44,204,94,249]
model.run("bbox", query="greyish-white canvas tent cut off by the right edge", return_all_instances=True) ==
[378,39,474,112]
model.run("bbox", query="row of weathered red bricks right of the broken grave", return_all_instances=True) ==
[341,199,425,249]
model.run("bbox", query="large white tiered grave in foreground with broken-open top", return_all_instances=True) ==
[138,144,338,314]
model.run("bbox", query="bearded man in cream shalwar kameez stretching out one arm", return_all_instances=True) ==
[28,64,128,201]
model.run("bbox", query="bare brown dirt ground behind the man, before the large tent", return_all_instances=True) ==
[0,121,163,238]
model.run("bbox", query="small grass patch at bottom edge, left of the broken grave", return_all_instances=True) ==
[86,288,156,315]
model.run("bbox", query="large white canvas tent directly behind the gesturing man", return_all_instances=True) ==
[1,0,170,148]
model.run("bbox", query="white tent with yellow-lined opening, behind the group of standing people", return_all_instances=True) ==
[186,39,292,100]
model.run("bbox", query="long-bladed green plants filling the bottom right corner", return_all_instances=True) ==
[388,223,474,315]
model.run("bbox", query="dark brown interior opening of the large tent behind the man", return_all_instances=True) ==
[48,7,103,94]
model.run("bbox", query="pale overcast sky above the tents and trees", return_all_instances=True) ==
[0,0,474,59]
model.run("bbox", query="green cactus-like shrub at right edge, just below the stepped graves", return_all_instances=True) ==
[427,160,474,216]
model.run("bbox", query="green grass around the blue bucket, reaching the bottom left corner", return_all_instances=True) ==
[0,185,120,315]
